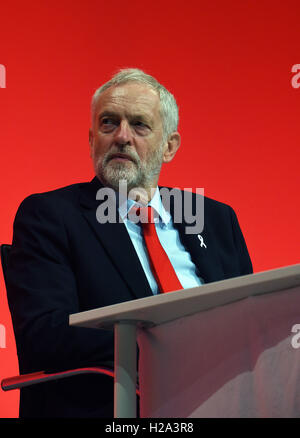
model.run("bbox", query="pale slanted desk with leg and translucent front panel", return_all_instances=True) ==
[69,264,300,418]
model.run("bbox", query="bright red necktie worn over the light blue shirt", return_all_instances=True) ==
[132,207,183,292]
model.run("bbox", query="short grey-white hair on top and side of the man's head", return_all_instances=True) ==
[91,68,179,143]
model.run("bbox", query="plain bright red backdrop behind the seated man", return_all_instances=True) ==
[0,0,300,417]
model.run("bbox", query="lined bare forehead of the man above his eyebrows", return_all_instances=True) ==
[96,82,160,117]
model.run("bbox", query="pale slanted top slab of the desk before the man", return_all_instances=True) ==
[69,264,300,328]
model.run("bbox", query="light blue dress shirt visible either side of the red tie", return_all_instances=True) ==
[119,187,203,294]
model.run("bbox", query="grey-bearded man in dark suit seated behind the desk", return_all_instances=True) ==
[8,69,252,417]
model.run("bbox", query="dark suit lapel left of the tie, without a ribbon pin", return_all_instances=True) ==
[80,178,152,298]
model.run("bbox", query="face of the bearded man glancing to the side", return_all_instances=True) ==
[90,82,167,196]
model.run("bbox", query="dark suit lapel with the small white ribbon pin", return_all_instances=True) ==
[162,187,224,283]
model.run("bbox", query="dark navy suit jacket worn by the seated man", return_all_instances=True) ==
[8,178,252,417]
